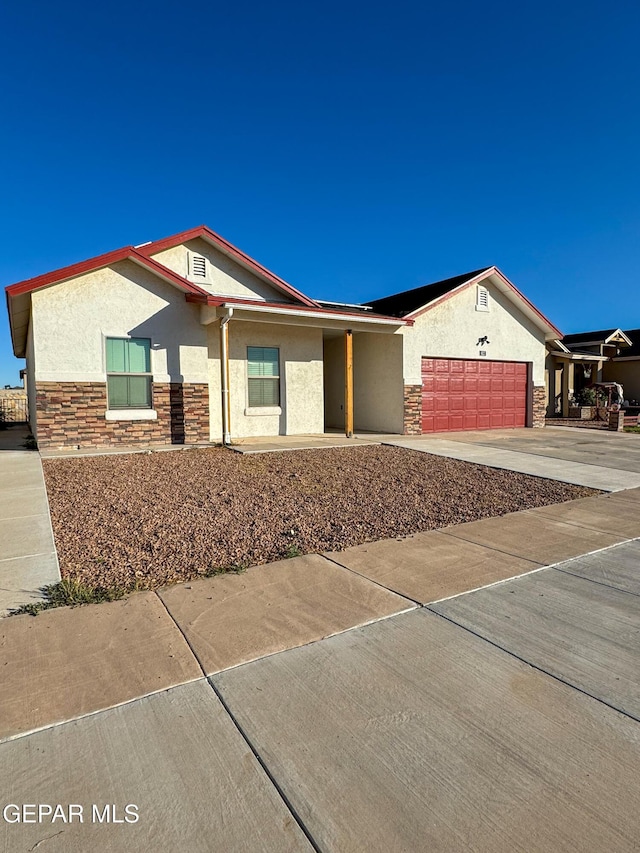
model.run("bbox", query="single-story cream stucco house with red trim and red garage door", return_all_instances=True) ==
[6,226,561,447]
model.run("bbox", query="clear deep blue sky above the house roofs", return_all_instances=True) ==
[0,0,640,385]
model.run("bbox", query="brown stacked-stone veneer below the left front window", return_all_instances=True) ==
[36,382,209,448]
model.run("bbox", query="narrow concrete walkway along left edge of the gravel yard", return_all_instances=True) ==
[0,427,60,616]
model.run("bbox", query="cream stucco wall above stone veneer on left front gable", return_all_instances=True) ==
[31,261,209,384]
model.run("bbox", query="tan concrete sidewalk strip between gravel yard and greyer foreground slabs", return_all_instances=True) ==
[0,489,640,741]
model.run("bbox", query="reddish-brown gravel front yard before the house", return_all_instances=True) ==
[43,445,597,588]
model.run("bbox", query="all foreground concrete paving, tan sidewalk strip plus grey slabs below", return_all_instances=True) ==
[0,489,640,853]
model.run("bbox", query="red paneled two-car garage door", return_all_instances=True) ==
[422,358,527,432]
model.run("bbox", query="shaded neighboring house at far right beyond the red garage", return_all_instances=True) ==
[546,329,640,417]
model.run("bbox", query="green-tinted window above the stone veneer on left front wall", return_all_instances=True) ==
[107,338,151,409]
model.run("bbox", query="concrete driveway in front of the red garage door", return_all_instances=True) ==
[385,427,640,491]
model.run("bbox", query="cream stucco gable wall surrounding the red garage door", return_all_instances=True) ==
[402,281,546,386]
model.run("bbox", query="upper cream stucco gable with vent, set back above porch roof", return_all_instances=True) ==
[153,238,292,302]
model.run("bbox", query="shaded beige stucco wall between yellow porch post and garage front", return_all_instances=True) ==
[353,332,404,433]
